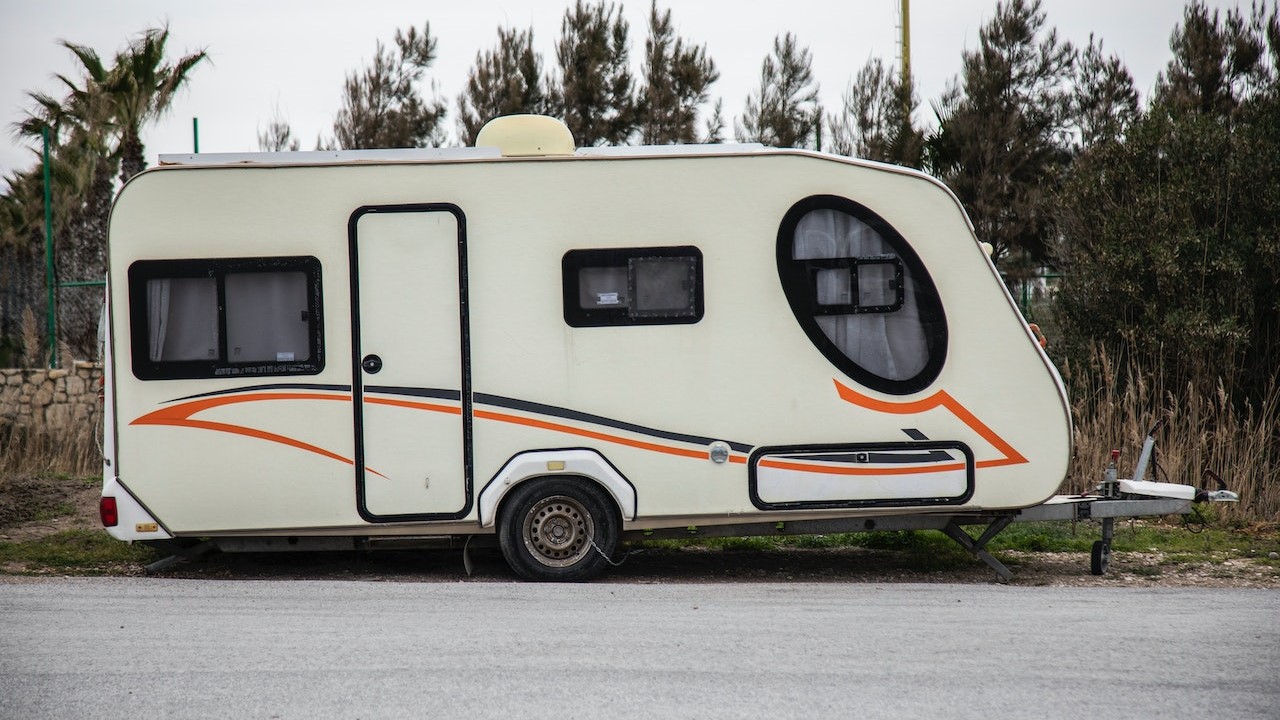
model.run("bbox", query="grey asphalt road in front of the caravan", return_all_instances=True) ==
[0,578,1280,720]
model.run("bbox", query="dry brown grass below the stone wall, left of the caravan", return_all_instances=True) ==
[0,411,102,478]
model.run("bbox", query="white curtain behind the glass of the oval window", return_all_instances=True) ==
[792,210,929,380]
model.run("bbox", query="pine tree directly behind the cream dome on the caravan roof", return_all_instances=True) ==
[458,28,550,145]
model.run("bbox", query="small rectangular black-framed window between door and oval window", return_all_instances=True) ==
[561,246,703,328]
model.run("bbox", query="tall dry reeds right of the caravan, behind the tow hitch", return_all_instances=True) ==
[1062,347,1280,523]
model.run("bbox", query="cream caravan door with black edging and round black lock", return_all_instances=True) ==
[348,205,471,523]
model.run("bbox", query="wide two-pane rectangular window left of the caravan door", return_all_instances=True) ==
[129,258,324,380]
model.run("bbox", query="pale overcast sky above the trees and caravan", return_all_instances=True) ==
[0,0,1247,176]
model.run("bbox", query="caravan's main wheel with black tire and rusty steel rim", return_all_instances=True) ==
[498,478,621,582]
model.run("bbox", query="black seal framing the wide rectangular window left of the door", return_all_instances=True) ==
[128,255,325,380]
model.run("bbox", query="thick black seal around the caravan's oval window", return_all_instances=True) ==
[776,195,948,395]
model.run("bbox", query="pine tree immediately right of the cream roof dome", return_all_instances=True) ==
[552,0,636,146]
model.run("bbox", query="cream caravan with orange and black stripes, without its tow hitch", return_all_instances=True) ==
[102,117,1071,579]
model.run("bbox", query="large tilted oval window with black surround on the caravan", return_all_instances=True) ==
[778,196,947,395]
